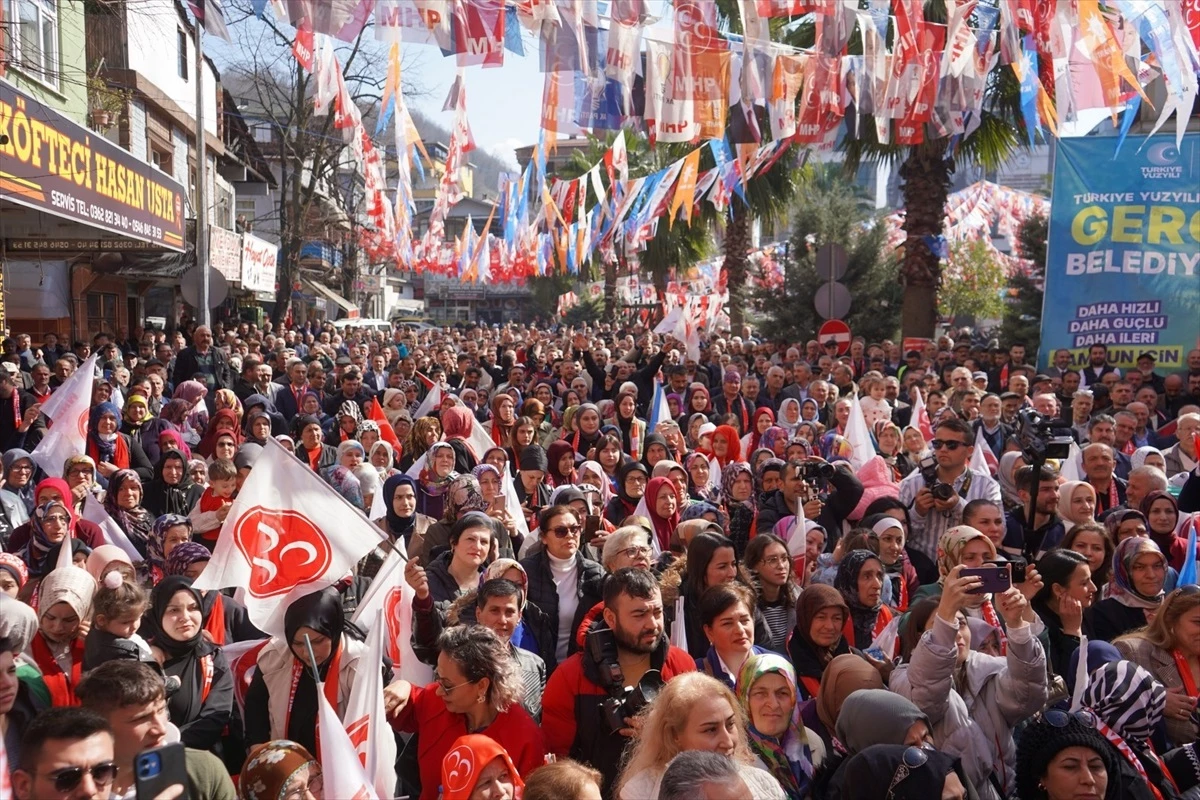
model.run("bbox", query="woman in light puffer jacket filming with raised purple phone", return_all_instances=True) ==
[889,551,1048,800]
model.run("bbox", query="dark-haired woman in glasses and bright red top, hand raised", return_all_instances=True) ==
[384,625,546,800]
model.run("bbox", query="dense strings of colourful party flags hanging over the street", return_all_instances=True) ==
[254,0,1200,282]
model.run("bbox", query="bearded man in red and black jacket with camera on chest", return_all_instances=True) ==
[541,567,696,796]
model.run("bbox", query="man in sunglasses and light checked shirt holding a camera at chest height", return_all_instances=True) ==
[900,417,1001,559]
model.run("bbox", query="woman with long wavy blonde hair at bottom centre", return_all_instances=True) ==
[616,673,785,800]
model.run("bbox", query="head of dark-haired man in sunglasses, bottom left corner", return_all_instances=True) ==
[12,706,118,800]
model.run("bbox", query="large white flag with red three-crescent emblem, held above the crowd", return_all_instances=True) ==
[196,439,384,636]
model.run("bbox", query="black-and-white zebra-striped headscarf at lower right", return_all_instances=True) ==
[1084,661,1166,746]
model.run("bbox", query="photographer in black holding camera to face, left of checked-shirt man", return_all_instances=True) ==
[758,456,863,551]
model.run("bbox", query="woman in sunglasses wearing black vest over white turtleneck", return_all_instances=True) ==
[521,505,604,673]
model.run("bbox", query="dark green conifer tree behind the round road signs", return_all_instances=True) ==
[755,166,904,342]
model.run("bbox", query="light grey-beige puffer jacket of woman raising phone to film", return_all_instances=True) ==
[889,615,1048,800]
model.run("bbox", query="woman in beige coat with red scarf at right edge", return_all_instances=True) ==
[1112,587,1200,745]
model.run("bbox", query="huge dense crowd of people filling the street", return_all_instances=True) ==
[0,323,1200,800]
